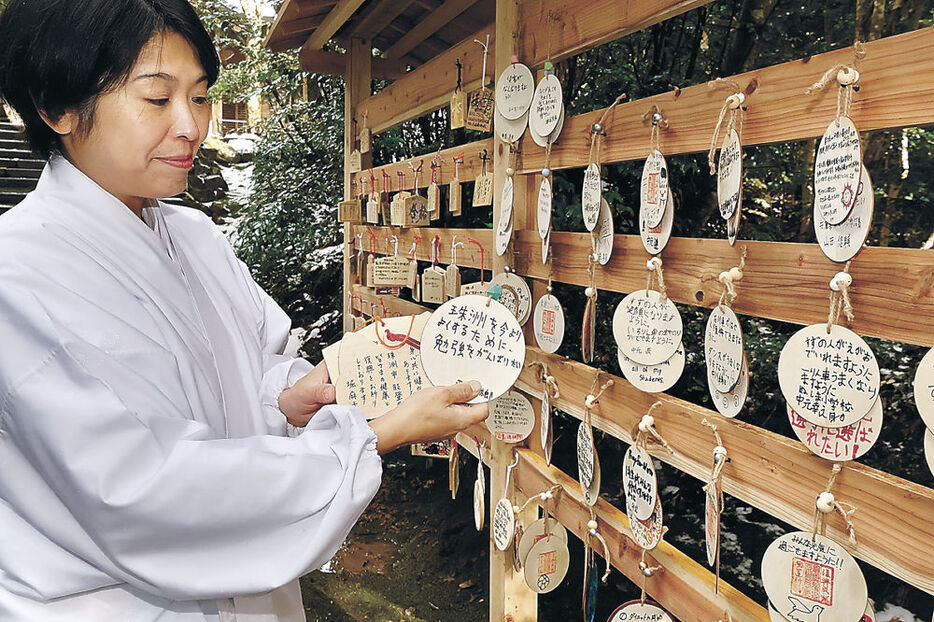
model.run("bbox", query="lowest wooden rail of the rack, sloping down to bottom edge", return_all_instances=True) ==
[516,449,769,622]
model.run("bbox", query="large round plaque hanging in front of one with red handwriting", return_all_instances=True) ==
[778,324,879,428]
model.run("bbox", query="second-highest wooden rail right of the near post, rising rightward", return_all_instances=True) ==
[522,25,934,172]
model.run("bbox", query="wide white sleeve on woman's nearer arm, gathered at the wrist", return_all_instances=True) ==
[0,340,382,600]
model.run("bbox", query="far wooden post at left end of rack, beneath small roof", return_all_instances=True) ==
[343,39,373,333]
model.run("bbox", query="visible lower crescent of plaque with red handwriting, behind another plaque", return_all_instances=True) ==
[785,397,883,462]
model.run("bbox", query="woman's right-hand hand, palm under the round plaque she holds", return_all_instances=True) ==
[370,380,490,454]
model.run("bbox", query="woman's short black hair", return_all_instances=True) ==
[0,0,220,157]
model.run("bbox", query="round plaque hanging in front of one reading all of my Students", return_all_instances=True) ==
[613,289,684,365]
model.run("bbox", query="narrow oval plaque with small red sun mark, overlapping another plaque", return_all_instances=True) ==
[814,117,862,225]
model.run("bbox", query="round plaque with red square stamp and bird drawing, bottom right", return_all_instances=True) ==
[762,531,868,622]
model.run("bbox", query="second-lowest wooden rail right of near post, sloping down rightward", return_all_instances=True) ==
[517,348,934,596]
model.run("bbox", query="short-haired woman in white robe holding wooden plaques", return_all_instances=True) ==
[0,0,486,622]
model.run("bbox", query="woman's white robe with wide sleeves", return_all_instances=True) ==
[0,157,382,622]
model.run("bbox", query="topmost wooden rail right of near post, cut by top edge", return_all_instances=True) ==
[518,0,710,69]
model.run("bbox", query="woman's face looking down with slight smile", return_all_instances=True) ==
[53,32,211,215]
